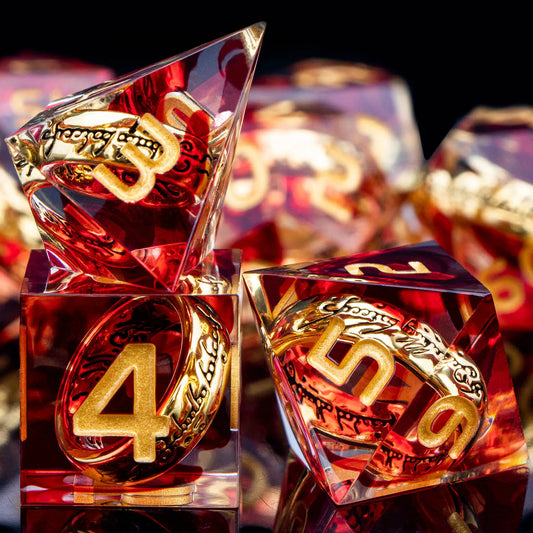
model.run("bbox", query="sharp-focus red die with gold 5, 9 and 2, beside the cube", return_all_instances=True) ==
[245,243,527,504]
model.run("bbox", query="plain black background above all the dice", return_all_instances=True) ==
[0,6,533,157]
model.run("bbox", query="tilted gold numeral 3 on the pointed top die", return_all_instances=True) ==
[92,113,180,203]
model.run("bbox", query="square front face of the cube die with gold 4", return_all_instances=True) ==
[21,251,240,507]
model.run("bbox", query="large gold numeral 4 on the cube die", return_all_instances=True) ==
[72,343,170,463]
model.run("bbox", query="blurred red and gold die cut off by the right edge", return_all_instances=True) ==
[413,107,533,330]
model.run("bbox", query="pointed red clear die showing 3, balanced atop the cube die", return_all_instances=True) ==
[7,24,264,291]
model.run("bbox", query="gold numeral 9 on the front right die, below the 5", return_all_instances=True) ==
[417,396,479,459]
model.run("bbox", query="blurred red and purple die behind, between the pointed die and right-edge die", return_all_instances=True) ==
[214,60,422,267]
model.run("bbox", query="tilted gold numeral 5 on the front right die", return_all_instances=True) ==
[307,317,394,406]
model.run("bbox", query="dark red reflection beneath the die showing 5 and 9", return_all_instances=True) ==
[274,456,529,533]
